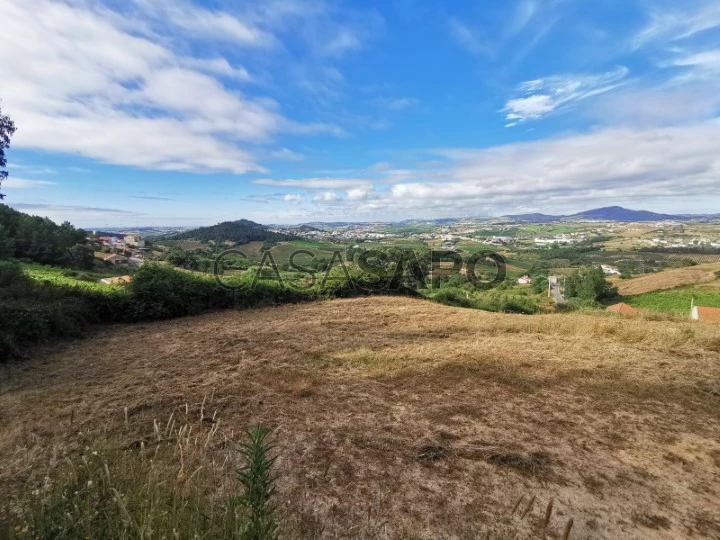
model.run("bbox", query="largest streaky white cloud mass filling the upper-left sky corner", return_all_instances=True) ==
[0,0,342,174]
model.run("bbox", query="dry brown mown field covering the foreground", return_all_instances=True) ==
[0,297,720,539]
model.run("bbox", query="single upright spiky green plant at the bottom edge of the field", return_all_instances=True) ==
[237,426,279,540]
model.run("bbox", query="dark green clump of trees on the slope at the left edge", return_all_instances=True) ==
[0,204,92,268]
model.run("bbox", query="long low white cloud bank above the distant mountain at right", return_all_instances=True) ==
[272,122,720,219]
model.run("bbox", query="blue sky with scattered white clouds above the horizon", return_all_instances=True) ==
[0,0,720,227]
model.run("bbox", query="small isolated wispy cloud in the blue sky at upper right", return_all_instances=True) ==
[501,66,629,123]
